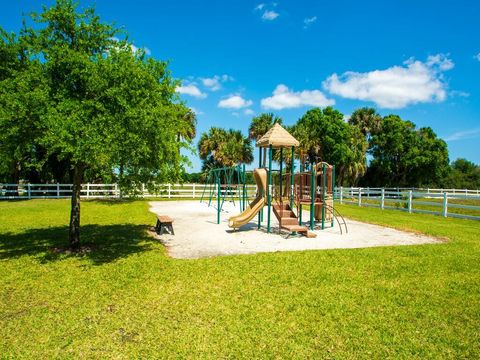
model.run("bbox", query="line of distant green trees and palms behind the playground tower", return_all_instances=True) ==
[195,107,480,188]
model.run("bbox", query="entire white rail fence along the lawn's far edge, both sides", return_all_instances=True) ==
[0,184,480,220]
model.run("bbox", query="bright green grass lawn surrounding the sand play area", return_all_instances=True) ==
[0,200,480,359]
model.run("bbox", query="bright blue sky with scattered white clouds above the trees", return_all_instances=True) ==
[0,0,480,171]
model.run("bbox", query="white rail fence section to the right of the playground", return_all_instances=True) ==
[335,187,480,220]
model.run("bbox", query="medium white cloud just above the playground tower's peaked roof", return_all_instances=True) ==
[261,84,335,110]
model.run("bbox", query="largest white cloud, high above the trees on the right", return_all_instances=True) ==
[323,54,454,109]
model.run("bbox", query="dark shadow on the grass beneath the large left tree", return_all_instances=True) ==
[0,224,156,265]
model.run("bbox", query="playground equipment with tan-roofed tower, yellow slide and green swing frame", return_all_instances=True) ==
[202,123,348,237]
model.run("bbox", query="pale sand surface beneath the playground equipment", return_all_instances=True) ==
[150,201,440,259]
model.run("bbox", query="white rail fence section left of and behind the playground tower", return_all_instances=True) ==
[0,183,257,200]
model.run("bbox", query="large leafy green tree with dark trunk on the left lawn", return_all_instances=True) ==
[2,0,191,247]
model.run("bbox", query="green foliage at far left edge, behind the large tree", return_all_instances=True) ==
[0,28,48,184]
